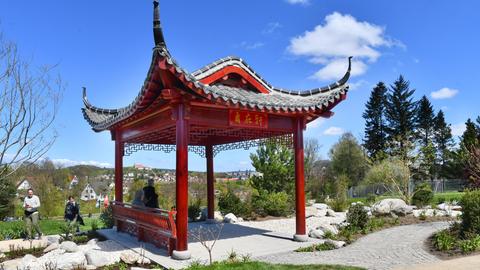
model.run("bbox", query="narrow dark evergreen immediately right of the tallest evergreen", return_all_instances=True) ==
[416,96,435,147]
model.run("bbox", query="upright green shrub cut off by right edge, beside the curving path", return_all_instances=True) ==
[460,190,480,236]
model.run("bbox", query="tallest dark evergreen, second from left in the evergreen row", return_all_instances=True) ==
[385,75,416,161]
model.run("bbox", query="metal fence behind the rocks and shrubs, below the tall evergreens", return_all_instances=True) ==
[348,179,468,198]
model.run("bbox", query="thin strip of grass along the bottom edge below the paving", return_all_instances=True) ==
[188,262,365,270]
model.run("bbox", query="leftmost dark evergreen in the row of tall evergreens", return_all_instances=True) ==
[363,82,387,159]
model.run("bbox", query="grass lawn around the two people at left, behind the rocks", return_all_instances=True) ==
[0,217,104,235]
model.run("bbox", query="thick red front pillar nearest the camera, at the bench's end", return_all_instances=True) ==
[172,103,191,260]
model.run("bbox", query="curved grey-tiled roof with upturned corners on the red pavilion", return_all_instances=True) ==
[82,1,351,132]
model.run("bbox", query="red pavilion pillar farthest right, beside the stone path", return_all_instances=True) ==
[293,118,308,242]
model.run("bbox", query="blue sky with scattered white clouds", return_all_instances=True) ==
[0,0,480,171]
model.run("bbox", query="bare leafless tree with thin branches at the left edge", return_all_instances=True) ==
[0,33,63,212]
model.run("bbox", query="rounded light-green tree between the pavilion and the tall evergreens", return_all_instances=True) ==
[330,133,367,187]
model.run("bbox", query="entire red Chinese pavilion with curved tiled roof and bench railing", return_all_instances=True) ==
[82,1,351,259]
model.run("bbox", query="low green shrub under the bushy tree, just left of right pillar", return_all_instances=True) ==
[252,191,292,217]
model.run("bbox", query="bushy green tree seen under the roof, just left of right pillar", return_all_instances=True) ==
[250,142,295,194]
